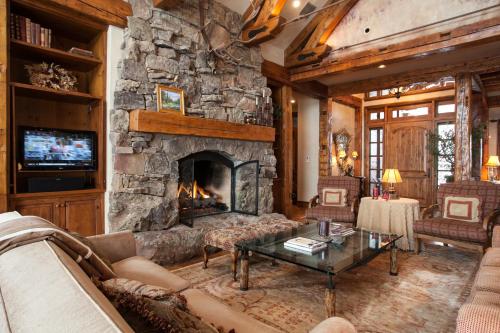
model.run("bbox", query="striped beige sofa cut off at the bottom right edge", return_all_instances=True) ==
[456,226,500,333]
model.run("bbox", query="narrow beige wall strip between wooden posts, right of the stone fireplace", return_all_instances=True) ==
[290,93,319,201]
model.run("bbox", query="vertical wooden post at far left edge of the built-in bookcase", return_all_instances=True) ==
[0,1,9,212]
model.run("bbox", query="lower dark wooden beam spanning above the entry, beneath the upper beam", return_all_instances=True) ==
[328,56,500,97]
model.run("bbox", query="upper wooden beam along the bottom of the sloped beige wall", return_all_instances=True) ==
[290,17,500,82]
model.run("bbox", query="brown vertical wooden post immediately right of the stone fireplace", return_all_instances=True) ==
[280,85,293,217]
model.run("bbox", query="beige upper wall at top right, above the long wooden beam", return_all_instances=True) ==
[327,0,500,56]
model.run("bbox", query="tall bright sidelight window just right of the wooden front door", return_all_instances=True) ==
[437,123,455,186]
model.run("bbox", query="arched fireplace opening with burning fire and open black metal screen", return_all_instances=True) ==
[177,150,259,226]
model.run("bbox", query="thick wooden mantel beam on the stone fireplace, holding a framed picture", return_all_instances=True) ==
[129,110,275,142]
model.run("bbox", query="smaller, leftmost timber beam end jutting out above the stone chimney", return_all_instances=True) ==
[241,0,287,46]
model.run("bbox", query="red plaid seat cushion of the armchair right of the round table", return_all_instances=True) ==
[413,217,488,244]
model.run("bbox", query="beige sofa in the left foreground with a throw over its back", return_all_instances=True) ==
[0,214,355,333]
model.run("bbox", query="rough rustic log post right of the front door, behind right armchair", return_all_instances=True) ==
[455,73,472,181]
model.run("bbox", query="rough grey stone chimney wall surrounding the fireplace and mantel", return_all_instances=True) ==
[109,0,276,231]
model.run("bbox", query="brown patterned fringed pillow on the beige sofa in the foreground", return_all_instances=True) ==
[94,278,220,333]
